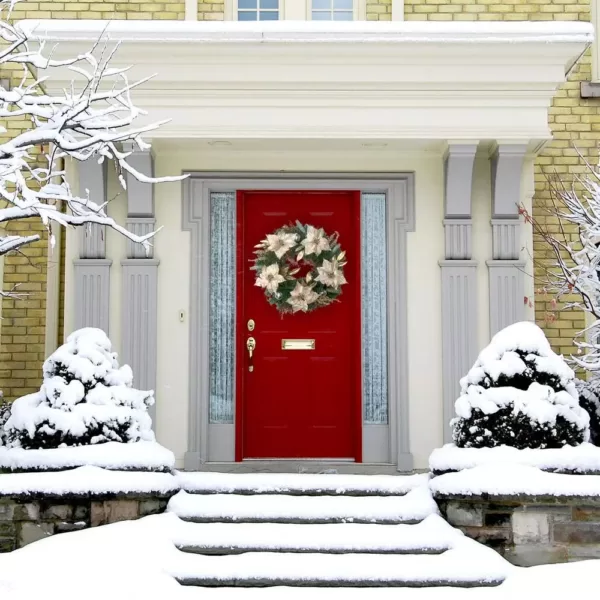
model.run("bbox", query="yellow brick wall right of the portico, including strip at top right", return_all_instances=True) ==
[404,0,600,355]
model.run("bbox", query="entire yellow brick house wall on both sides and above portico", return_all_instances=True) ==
[0,0,600,398]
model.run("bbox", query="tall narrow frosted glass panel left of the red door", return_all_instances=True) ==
[209,192,236,423]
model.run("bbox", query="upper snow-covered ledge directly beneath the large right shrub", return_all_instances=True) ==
[429,444,600,473]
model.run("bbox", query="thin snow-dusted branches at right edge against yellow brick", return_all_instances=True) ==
[520,157,600,372]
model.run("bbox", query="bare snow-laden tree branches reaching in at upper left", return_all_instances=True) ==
[0,0,183,284]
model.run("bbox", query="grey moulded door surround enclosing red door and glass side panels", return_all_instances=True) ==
[182,171,415,472]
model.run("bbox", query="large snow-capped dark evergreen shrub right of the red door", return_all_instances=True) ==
[451,322,589,448]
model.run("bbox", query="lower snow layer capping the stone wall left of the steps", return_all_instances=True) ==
[0,466,179,496]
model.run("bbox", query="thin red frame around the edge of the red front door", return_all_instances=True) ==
[234,188,364,464]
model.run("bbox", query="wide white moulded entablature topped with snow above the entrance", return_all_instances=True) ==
[23,19,593,149]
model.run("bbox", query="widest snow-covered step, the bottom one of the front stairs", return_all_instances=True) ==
[169,540,509,587]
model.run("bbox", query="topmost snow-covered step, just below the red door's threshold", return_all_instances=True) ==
[177,471,429,496]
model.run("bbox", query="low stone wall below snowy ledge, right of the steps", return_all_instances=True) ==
[437,496,600,567]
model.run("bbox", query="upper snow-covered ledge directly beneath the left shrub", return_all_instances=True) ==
[0,441,175,471]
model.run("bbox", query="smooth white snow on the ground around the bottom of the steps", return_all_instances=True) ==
[0,514,600,600]
